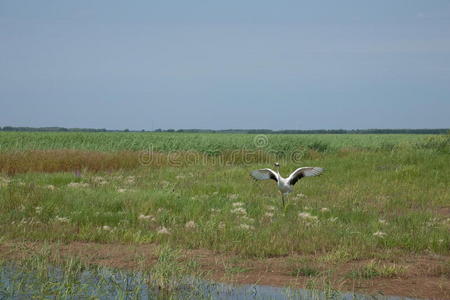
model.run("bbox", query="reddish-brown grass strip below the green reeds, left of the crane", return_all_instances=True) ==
[0,150,276,175]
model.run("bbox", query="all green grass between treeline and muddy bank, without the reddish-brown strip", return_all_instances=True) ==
[0,133,450,263]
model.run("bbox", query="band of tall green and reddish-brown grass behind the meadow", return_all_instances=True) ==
[0,132,450,175]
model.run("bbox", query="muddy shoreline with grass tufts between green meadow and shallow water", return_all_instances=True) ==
[0,242,450,299]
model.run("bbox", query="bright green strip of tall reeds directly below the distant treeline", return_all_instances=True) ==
[0,132,438,154]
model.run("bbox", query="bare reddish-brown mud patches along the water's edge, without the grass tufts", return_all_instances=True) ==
[0,242,450,299]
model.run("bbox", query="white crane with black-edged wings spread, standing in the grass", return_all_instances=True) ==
[251,163,324,206]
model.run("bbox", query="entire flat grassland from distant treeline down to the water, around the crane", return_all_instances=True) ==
[0,132,450,298]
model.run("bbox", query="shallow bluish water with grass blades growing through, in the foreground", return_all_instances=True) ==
[0,265,420,300]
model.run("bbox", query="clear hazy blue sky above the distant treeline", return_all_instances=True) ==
[0,0,450,130]
